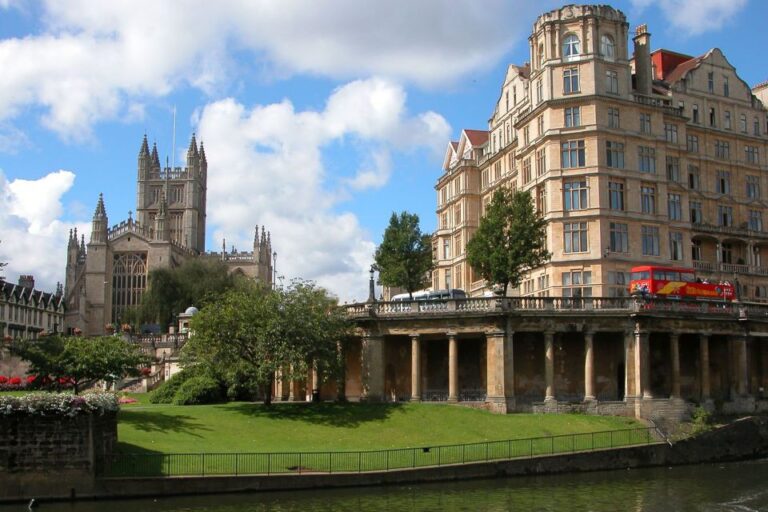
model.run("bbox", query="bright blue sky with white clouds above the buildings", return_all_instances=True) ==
[0,0,768,301]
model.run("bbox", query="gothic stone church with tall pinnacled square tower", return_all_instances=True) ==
[64,135,273,336]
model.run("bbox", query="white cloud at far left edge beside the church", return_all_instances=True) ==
[0,170,88,291]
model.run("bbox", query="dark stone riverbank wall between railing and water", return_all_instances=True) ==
[5,417,768,501]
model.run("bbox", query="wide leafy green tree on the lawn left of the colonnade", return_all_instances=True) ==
[182,281,349,405]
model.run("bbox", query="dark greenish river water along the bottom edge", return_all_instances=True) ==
[6,459,768,512]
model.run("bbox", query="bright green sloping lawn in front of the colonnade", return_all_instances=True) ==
[118,402,642,453]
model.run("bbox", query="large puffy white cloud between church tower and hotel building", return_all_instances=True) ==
[198,78,450,300]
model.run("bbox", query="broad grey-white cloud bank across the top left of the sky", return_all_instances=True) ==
[0,0,540,141]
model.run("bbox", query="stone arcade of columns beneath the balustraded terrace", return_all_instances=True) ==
[275,304,768,419]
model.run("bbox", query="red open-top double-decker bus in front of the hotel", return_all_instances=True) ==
[629,265,736,301]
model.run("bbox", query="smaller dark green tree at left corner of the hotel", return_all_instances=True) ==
[374,212,432,298]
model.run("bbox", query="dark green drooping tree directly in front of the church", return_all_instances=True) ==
[129,259,237,326]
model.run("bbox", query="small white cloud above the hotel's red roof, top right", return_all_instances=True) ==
[632,0,748,36]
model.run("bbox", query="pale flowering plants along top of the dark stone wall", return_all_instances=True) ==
[0,393,119,417]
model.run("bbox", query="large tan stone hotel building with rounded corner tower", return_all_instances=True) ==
[432,5,768,301]
